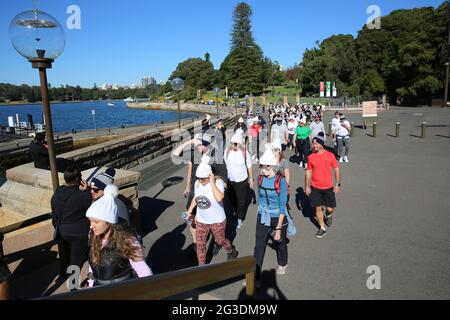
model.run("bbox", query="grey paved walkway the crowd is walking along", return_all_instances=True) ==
[134,108,450,299]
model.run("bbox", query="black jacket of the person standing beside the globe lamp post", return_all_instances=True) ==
[51,186,92,239]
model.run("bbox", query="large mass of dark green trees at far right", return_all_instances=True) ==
[298,2,448,98]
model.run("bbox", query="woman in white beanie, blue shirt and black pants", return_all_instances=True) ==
[253,145,288,286]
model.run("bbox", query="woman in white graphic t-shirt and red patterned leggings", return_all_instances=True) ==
[186,157,238,265]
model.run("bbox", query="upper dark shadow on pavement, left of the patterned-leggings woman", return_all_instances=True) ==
[139,197,175,237]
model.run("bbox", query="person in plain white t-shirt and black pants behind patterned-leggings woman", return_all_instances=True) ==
[224,132,255,229]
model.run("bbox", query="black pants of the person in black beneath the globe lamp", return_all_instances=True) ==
[58,234,88,274]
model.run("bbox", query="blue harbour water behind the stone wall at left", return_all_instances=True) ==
[0,100,197,133]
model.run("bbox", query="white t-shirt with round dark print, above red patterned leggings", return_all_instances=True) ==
[195,179,226,224]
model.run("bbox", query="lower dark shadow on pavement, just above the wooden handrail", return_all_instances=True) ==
[146,223,197,274]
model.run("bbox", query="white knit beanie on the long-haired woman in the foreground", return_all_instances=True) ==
[86,184,119,224]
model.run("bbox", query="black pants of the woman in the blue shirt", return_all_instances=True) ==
[253,214,288,280]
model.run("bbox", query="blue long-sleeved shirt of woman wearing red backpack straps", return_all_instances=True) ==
[258,175,287,226]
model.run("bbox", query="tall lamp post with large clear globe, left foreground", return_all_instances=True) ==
[9,8,65,190]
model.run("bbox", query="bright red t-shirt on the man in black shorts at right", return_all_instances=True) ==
[308,150,338,190]
